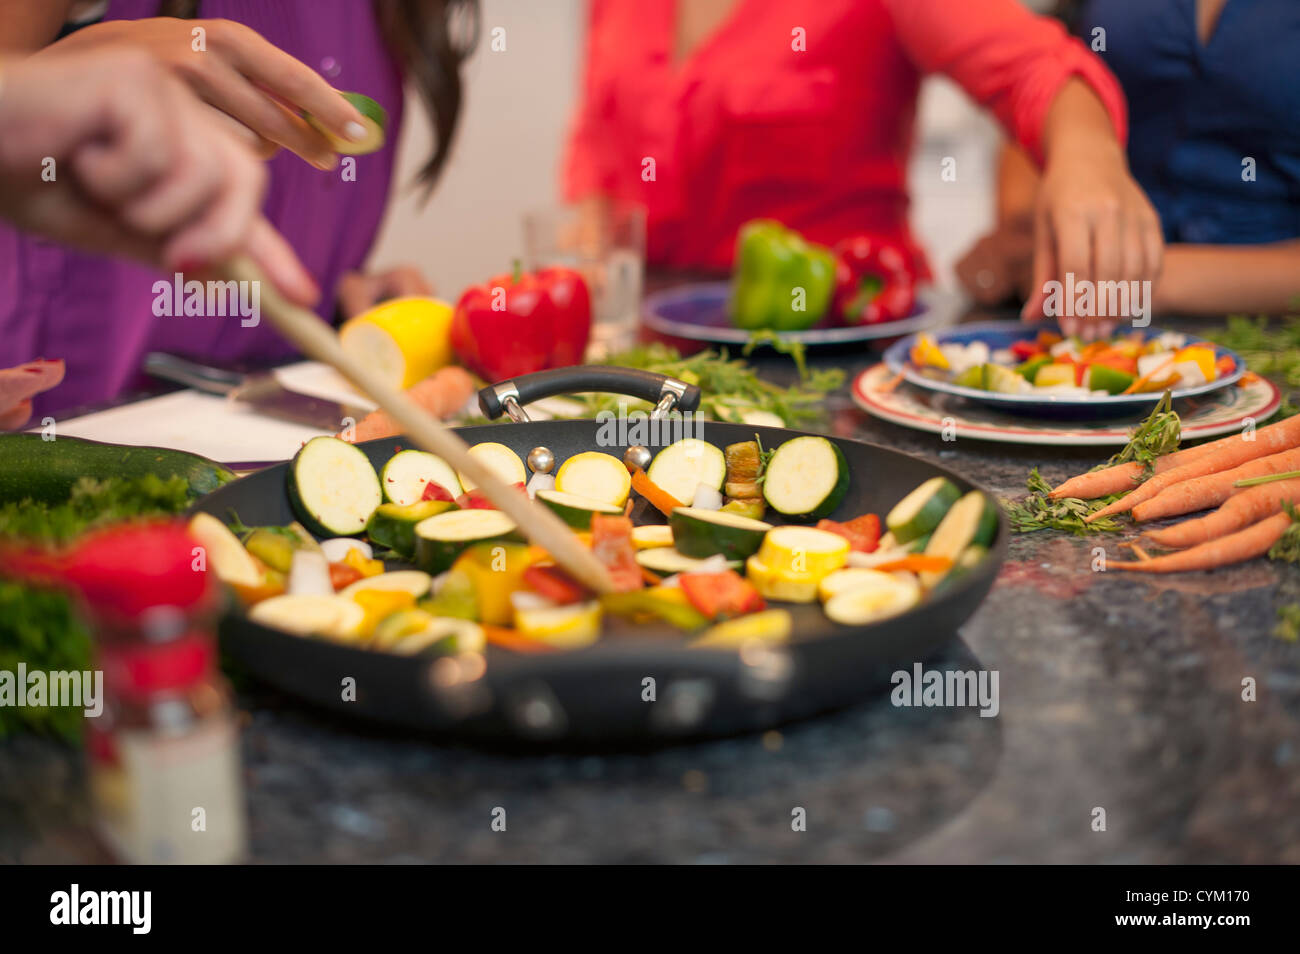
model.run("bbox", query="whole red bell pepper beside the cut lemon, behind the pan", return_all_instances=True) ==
[451,263,592,381]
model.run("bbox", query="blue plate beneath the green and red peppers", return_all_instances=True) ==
[641,282,963,347]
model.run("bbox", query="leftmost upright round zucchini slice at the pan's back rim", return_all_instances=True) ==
[287,437,384,537]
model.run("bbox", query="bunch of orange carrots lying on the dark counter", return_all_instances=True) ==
[1050,416,1300,573]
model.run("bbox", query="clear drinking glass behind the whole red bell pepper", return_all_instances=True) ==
[524,200,646,361]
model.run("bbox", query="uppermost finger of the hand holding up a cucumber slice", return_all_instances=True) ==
[217,23,365,151]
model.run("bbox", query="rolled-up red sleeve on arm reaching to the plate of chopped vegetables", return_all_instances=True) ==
[884,0,1128,165]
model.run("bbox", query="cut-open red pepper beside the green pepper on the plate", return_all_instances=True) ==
[835,235,917,325]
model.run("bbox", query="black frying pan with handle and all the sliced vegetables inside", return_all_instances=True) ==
[190,367,1006,743]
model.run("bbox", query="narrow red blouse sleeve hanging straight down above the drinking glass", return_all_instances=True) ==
[560,0,616,201]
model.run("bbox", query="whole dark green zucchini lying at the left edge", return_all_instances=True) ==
[0,434,235,503]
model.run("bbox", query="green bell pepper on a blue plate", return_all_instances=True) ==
[728,218,836,331]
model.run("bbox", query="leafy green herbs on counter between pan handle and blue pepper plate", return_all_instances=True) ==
[577,342,844,426]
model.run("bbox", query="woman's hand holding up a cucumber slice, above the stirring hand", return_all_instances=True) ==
[46,17,365,169]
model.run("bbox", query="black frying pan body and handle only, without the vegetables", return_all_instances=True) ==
[195,367,1008,743]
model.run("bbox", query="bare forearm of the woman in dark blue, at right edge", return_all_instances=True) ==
[1156,239,1300,315]
